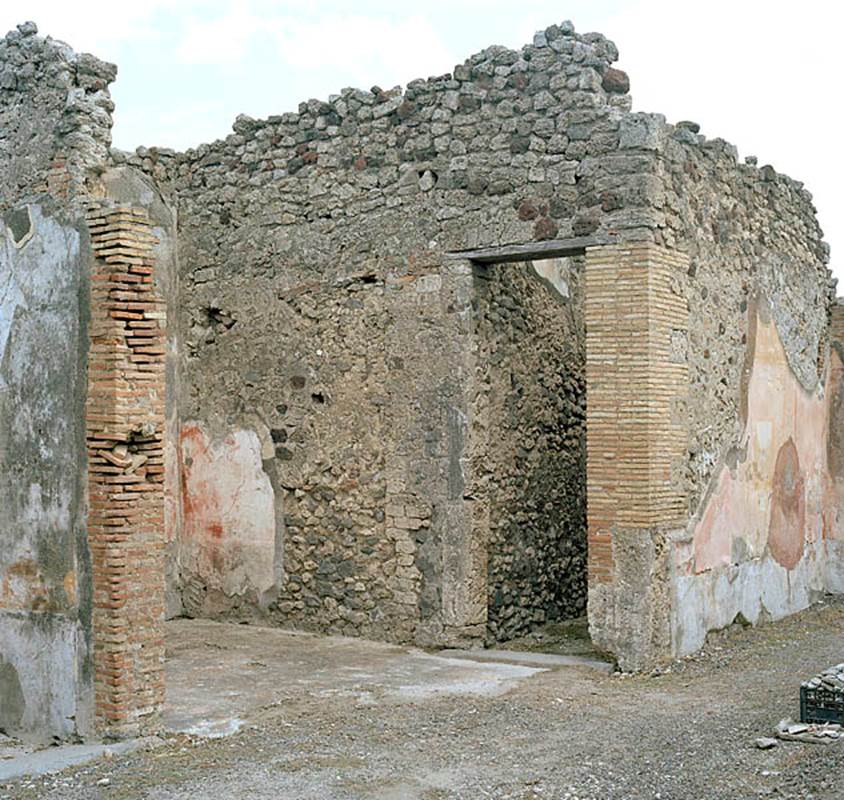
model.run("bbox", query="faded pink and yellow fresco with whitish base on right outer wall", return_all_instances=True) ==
[672,303,844,655]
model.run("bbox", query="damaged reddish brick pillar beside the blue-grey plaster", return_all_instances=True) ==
[87,202,166,736]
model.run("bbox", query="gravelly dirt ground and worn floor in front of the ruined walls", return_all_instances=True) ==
[0,602,844,800]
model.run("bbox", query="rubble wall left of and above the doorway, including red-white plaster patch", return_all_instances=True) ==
[123,21,654,641]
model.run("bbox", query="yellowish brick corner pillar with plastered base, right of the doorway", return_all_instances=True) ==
[585,242,688,668]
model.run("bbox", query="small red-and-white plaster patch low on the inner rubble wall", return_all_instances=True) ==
[180,422,281,615]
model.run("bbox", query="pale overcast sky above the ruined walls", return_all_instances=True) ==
[0,0,844,282]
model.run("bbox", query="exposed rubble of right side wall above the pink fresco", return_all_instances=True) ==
[654,119,835,514]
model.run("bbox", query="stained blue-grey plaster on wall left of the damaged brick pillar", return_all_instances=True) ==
[0,203,91,739]
